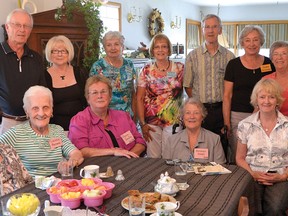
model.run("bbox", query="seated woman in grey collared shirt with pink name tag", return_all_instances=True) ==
[162,98,226,164]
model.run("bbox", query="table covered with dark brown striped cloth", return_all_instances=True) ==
[0,156,254,216]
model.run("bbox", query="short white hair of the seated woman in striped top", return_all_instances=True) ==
[23,85,53,110]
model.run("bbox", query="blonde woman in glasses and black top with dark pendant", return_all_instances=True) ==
[45,35,87,131]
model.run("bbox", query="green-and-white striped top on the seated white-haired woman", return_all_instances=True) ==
[0,122,76,177]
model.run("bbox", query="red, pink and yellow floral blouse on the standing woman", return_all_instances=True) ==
[138,61,184,126]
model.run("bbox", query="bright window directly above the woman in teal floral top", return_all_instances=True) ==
[99,1,121,32]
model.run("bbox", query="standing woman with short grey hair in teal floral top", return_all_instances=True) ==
[90,31,136,120]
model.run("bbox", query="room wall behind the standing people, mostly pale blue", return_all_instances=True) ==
[0,0,288,49]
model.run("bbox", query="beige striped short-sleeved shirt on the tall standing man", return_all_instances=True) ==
[183,43,235,103]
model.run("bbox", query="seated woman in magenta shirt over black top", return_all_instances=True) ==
[68,75,146,158]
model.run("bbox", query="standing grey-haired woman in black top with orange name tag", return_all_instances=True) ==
[223,25,275,163]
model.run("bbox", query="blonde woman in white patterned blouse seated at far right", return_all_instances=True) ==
[236,79,288,216]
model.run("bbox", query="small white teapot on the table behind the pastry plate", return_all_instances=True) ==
[154,172,179,196]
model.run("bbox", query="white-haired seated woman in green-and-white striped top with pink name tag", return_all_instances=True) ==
[0,86,84,176]
